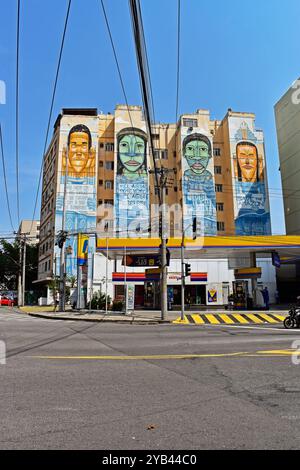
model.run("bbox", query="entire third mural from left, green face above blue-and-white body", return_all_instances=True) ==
[182,128,217,236]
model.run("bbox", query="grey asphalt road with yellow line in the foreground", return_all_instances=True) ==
[0,308,300,449]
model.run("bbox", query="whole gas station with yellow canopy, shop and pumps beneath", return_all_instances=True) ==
[96,235,300,309]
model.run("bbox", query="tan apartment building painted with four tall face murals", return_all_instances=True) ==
[38,105,271,304]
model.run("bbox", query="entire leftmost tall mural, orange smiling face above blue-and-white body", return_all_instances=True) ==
[55,118,97,275]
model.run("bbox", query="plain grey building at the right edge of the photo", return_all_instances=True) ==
[275,81,300,235]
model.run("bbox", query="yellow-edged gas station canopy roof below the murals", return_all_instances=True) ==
[97,235,300,260]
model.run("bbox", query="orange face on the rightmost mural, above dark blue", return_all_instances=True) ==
[236,142,258,183]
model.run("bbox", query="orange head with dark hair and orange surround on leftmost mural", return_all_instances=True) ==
[63,124,95,177]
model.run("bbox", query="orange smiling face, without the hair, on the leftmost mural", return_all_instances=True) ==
[69,132,89,176]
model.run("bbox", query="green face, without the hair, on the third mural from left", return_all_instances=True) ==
[184,139,210,175]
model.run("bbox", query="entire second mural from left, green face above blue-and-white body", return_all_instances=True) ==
[114,128,149,237]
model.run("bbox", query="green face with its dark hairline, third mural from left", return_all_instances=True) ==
[183,134,211,175]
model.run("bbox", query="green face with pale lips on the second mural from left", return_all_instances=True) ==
[118,134,146,173]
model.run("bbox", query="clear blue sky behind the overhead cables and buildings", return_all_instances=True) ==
[0,0,300,233]
